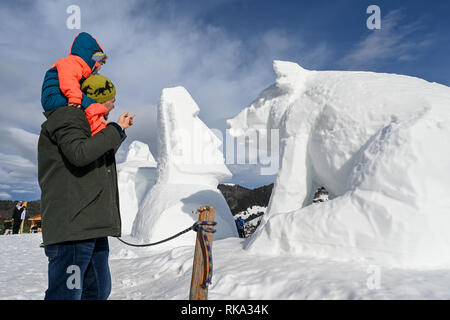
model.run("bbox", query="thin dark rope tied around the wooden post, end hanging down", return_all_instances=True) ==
[117,221,217,288]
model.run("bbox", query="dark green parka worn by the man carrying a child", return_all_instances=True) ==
[38,107,126,245]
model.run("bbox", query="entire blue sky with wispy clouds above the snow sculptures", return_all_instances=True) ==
[0,0,450,200]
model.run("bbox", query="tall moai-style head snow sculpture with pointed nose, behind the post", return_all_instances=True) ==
[132,87,237,247]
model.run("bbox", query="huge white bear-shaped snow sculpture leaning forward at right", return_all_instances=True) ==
[228,61,450,268]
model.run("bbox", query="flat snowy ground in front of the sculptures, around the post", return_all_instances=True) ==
[0,234,450,300]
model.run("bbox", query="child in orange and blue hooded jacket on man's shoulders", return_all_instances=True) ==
[41,32,108,135]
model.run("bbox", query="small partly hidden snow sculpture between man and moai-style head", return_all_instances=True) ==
[117,140,156,234]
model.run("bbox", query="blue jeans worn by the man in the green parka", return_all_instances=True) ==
[45,237,111,300]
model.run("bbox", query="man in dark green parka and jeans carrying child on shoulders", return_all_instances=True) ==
[38,78,134,300]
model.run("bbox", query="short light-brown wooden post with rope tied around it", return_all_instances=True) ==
[189,206,216,300]
